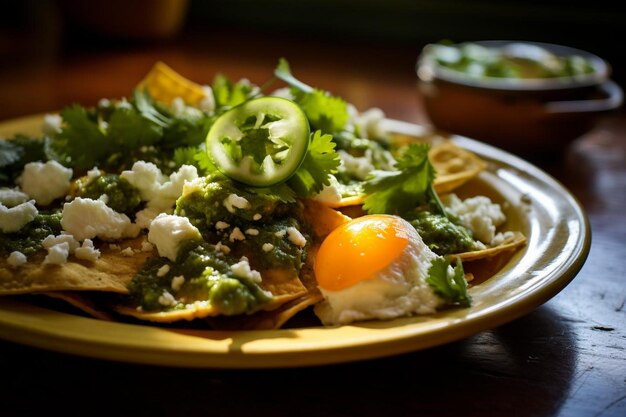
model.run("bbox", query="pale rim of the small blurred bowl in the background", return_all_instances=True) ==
[416,40,611,91]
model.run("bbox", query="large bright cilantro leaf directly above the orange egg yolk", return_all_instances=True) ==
[363,144,441,215]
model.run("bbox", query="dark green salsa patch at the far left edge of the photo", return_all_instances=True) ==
[0,212,62,256]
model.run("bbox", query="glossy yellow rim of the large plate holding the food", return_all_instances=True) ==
[0,114,591,369]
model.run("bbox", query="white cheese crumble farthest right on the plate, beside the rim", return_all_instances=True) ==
[442,194,506,245]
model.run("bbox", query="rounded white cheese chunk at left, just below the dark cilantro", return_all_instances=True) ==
[16,161,72,206]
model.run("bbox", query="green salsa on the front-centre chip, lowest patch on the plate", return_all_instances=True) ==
[129,241,271,315]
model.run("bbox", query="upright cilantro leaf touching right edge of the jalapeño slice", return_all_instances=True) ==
[287,130,340,197]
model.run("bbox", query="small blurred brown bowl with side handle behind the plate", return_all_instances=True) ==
[417,41,623,154]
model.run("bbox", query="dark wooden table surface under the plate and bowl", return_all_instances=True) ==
[0,31,626,417]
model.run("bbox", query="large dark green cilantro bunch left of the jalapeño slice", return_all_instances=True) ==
[50,90,213,172]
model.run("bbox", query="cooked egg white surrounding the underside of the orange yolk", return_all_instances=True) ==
[314,222,443,325]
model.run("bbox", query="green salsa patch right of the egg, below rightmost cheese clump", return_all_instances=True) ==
[409,211,475,255]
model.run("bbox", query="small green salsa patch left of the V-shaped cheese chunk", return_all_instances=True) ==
[77,174,141,215]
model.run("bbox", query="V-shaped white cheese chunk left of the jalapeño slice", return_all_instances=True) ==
[120,161,198,212]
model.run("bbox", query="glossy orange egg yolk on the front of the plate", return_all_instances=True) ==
[315,215,409,291]
